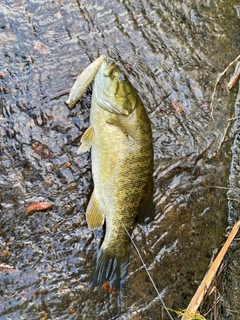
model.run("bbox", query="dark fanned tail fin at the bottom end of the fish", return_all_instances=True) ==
[92,248,129,290]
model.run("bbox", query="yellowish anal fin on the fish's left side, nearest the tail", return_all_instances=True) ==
[86,191,105,230]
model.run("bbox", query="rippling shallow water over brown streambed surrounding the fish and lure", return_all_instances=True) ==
[0,0,240,320]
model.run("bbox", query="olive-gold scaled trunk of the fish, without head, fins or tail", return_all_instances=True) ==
[91,100,152,235]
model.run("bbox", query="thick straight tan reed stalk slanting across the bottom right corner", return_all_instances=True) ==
[182,219,240,320]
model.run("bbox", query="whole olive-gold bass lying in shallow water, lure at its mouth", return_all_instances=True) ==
[67,59,154,290]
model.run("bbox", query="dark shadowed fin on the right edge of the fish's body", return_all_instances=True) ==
[136,179,154,224]
